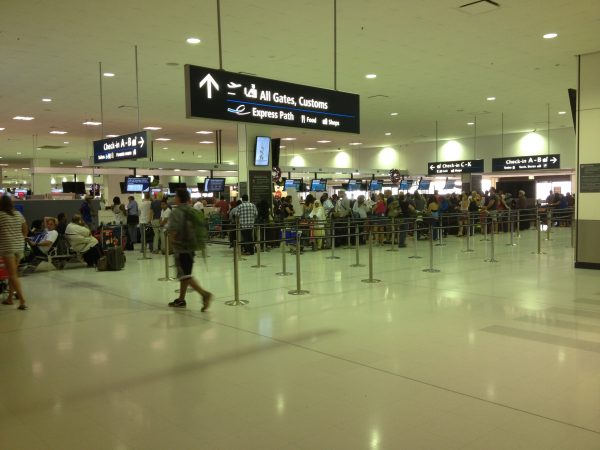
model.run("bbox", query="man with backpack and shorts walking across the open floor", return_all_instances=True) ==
[167,189,213,312]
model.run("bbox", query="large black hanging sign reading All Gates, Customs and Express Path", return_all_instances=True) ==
[185,64,360,133]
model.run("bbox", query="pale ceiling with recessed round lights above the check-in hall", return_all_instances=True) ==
[0,0,600,176]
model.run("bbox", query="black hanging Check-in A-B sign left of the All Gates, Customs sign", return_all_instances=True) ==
[94,131,152,163]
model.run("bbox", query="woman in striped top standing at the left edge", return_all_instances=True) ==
[0,195,27,310]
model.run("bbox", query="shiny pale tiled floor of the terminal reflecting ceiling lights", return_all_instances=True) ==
[0,228,600,450]
